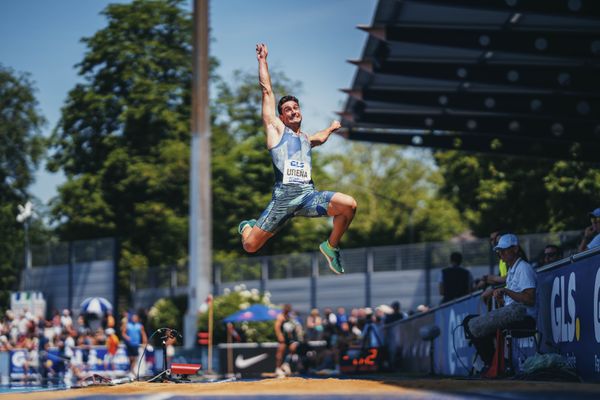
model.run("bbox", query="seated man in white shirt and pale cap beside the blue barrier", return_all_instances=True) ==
[464,234,537,367]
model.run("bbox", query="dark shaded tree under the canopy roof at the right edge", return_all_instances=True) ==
[435,151,600,236]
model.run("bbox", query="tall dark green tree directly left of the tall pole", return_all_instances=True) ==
[48,0,192,296]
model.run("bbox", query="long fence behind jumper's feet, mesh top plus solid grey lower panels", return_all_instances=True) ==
[131,231,581,306]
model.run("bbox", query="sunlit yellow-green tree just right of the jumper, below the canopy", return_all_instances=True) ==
[327,143,466,247]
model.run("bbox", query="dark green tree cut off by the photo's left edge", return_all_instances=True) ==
[0,65,45,308]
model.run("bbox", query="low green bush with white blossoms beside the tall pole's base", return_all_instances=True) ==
[198,284,275,343]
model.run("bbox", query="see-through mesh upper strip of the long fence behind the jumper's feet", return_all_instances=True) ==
[130,231,581,289]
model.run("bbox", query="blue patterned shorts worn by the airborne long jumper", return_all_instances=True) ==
[256,183,335,233]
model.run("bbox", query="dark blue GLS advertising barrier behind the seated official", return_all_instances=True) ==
[385,249,600,382]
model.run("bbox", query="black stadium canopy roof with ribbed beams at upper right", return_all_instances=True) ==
[340,0,600,162]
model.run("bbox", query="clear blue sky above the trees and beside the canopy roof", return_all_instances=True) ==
[0,0,377,204]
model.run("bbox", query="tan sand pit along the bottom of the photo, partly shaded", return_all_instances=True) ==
[0,376,600,400]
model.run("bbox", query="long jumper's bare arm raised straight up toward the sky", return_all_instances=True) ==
[256,43,285,149]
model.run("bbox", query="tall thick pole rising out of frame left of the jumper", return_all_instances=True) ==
[184,0,212,349]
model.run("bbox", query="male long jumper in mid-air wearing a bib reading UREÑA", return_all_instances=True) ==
[238,43,356,274]
